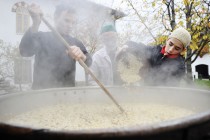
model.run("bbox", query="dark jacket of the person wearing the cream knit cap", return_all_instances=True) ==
[116,41,185,86]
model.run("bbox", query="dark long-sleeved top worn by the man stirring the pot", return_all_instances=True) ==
[19,29,92,89]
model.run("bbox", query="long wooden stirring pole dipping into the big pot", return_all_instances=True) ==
[42,17,125,113]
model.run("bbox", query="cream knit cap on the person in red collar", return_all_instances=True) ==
[169,27,191,47]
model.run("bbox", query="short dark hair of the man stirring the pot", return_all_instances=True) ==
[54,4,76,17]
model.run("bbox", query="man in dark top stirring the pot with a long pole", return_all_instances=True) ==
[19,4,92,89]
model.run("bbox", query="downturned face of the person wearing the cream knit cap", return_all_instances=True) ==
[165,38,184,55]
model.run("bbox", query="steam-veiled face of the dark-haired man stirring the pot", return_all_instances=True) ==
[55,11,76,35]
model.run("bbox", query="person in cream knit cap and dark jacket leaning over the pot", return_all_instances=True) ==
[115,28,191,86]
